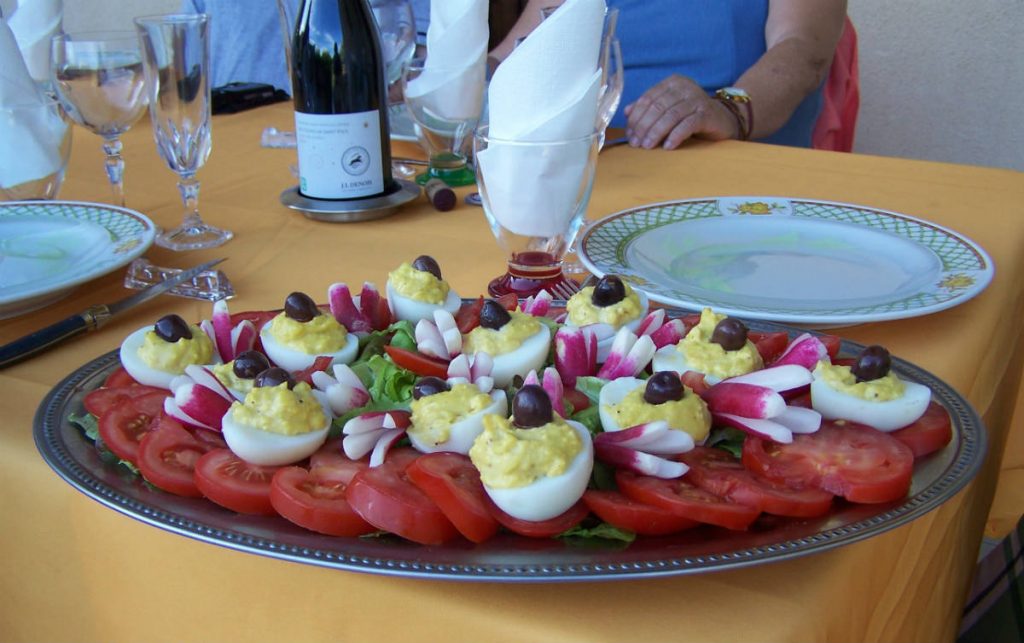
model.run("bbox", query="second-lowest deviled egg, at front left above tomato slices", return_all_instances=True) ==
[221,368,331,466]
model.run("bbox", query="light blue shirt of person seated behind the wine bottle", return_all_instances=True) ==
[181,0,430,91]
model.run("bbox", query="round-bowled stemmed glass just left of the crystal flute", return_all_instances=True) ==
[50,31,146,206]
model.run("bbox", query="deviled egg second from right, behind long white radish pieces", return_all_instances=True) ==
[651,308,765,384]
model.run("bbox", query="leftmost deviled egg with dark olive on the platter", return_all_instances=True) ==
[121,314,220,389]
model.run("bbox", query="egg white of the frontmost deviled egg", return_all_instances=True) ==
[483,420,594,522]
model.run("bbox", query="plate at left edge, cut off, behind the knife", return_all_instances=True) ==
[0,201,156,318]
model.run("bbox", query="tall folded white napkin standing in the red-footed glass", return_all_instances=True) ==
[476,0,606,237]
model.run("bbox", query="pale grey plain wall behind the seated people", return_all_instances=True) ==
[0,0,1024,171]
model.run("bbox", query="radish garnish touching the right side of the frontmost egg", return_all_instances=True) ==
[594,420,693,478]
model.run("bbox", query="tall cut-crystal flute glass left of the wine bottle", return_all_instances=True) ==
[135,13,233,250]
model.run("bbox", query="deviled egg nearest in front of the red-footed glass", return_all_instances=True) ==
[462,299,551,388]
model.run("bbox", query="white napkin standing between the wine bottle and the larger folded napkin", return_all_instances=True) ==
[406,0,489,120]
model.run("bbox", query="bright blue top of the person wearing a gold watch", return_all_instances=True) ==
[608,0,823,147]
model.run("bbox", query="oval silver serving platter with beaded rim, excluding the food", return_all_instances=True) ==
[34,319,986,583]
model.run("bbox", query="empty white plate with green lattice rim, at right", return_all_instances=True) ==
[579,197,993,326]
